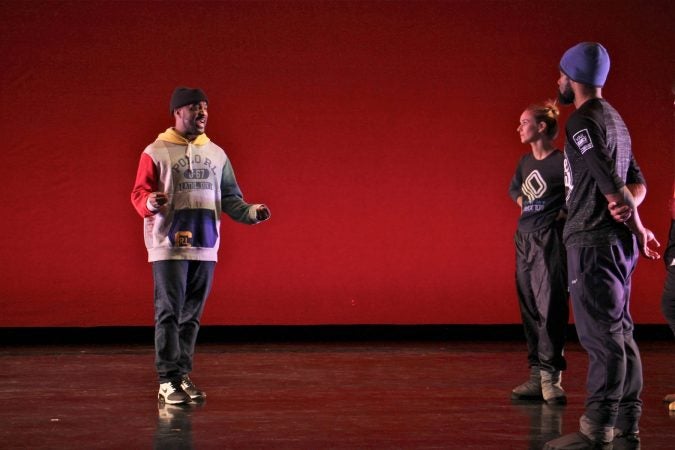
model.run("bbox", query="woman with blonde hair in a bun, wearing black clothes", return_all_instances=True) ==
[509,102,569,404]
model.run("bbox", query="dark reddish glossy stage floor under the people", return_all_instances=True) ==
[0,340,675,450]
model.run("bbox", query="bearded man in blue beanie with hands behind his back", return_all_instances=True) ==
[544,42,659,450]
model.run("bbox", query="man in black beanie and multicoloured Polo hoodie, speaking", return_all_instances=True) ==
[131,87,270,404]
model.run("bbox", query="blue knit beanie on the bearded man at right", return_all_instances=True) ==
[560,42,609,87]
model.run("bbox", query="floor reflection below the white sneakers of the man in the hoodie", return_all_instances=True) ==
[154,401,205,450]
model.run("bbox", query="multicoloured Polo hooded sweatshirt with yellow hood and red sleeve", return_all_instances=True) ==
[131,128,258,262]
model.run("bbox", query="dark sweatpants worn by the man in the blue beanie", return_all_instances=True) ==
[567,237,642,435]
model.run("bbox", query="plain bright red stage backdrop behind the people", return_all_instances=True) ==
[0,0,675,327]
